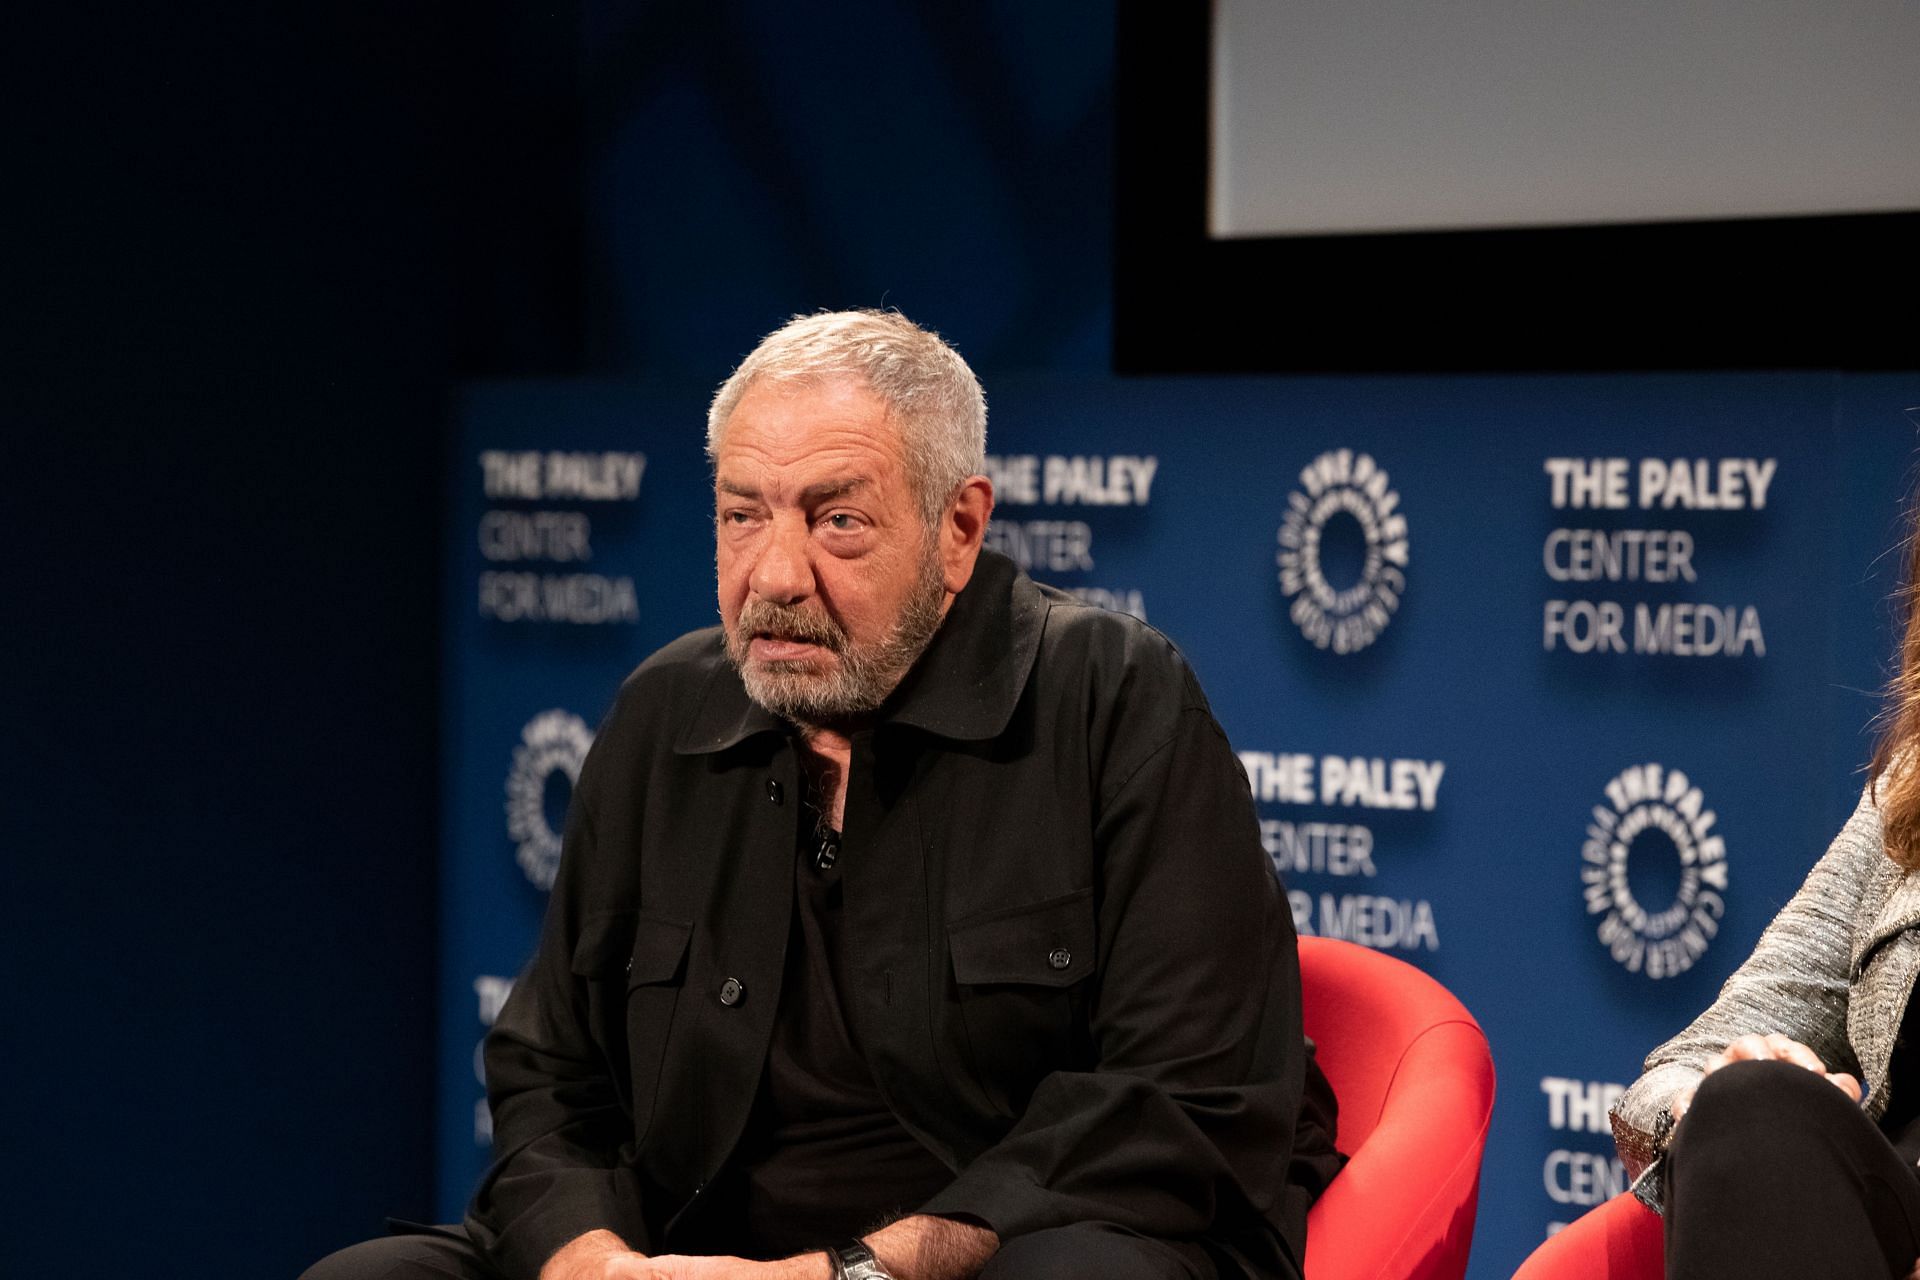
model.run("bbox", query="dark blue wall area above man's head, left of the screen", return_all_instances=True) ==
[582,0,1114,382]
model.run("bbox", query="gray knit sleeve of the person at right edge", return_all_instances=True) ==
[1611,789,1887,1213]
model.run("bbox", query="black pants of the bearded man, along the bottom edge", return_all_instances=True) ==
[301,1222,1240,1280]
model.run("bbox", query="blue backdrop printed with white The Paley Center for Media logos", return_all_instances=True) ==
[440,374,1920,1278]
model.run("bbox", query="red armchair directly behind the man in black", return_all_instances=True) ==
[1300,938,1494,1280]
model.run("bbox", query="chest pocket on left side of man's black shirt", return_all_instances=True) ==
[572,912,693,1142]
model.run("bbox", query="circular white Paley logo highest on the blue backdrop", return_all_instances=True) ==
[1275,449,1407,652]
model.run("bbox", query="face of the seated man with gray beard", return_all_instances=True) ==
[714,378,950,725]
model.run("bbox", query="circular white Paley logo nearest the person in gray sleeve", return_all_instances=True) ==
[1580,764,1726,979]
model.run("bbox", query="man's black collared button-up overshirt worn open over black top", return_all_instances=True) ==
[468,553,1331,1276]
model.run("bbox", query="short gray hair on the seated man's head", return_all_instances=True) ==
[707,311,987,528]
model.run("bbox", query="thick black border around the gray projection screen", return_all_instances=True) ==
[1114,0,1920,374]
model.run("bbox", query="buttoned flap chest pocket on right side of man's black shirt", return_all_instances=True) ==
[947,889,1096,1115]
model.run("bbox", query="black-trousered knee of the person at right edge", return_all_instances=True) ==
[1667,1061,1920,1280]
